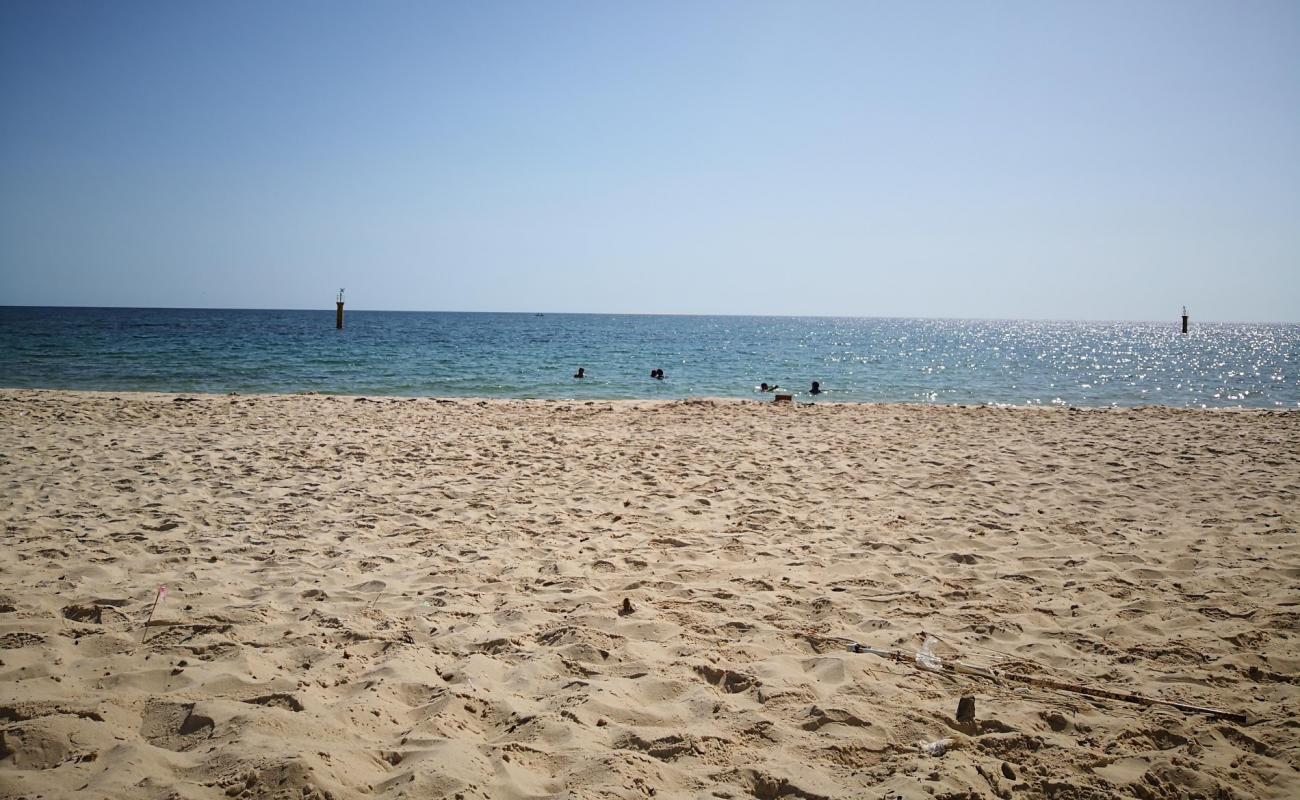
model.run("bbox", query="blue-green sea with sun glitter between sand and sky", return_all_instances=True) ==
[0,307,1300,408]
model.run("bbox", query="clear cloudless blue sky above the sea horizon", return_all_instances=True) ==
[0,0,1300,321]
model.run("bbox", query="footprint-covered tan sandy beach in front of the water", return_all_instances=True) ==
[0,390,1300,800]
